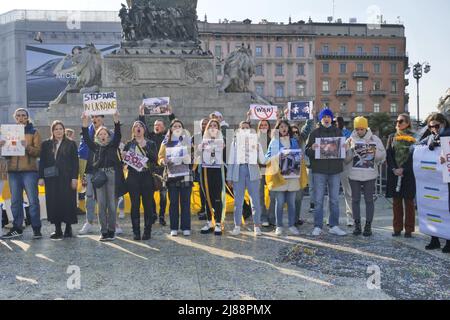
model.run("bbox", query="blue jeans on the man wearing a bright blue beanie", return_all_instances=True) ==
[313,173,341,229]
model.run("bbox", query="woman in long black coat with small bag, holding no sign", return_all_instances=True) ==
[39,121,78,240]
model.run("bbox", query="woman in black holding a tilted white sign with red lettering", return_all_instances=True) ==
[122,121,158,241]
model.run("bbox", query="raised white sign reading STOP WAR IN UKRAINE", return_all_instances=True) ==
[83,92,117,116]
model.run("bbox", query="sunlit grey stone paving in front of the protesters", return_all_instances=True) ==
[0,198,450,300]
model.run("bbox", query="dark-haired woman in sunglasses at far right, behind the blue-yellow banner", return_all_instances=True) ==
[419,113,450,253]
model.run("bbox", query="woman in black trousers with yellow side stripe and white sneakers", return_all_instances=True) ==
[197,119,226,236]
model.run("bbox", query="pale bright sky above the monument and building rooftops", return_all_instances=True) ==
[0,0,450,117]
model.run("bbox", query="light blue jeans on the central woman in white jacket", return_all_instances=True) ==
[233,165,261,226]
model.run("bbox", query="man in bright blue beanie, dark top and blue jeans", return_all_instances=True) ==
[305,108,347,236]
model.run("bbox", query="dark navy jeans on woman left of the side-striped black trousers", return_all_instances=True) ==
[168,186,192,231]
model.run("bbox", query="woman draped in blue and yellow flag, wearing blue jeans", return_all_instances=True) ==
[266,120,308,236]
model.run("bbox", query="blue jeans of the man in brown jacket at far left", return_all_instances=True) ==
[8,172,41,230]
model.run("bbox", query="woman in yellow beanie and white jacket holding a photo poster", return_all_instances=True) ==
[345,117,386,237]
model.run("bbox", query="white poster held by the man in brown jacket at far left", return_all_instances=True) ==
[0,124,25,157]
